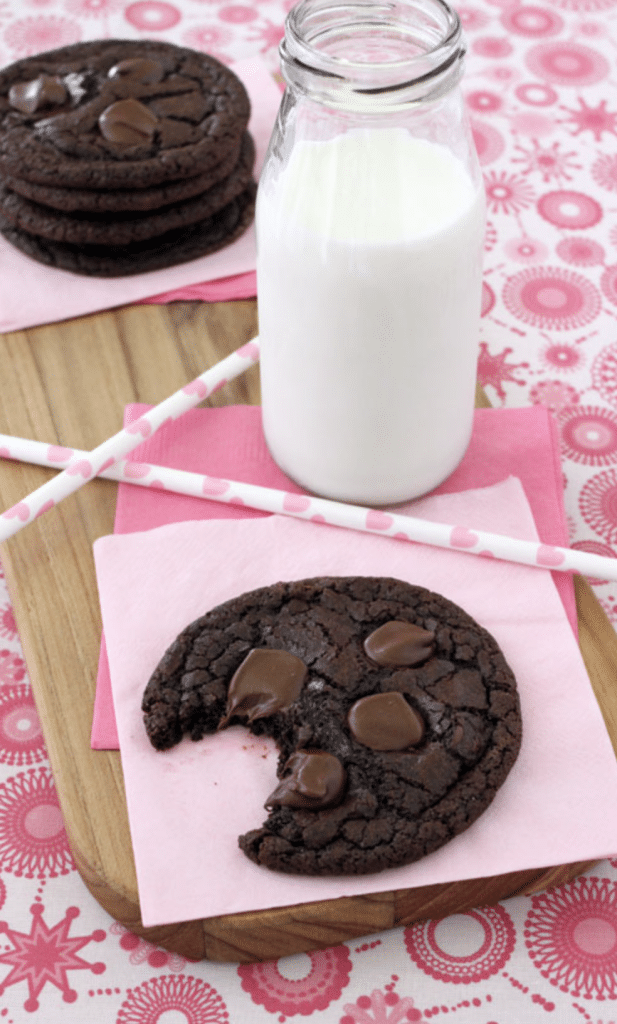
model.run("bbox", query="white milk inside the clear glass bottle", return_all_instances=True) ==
[256,127,484,505]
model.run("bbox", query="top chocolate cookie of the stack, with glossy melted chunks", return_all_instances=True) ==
[0,40,250,189]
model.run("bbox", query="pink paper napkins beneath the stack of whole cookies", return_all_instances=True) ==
[0,57,280,331]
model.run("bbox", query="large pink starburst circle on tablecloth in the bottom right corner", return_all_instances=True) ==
[524,878,617,999]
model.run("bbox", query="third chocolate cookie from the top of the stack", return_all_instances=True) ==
[0,133,255,246]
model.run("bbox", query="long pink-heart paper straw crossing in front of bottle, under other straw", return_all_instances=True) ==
[0,434,617,581]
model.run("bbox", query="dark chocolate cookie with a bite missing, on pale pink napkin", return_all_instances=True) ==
[142,577,522,874]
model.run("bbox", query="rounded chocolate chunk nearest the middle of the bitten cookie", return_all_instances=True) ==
[347,690,425,751]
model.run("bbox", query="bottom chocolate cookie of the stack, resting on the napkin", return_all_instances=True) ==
[0,184,256,278]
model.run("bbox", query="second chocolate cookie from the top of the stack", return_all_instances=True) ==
[4,132,249,213]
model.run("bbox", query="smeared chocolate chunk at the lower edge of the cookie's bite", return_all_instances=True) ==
[264,751,347,810]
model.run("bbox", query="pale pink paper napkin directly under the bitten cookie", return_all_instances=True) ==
[94,477,617,926]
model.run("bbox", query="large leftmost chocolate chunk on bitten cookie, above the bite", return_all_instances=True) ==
[219,647,308,728]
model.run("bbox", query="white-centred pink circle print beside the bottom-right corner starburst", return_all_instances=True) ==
[405,905,516,985]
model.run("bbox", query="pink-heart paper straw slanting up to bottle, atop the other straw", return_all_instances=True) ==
[0,338,259,542]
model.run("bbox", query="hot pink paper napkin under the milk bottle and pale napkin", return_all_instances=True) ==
[91,406,576,750]
